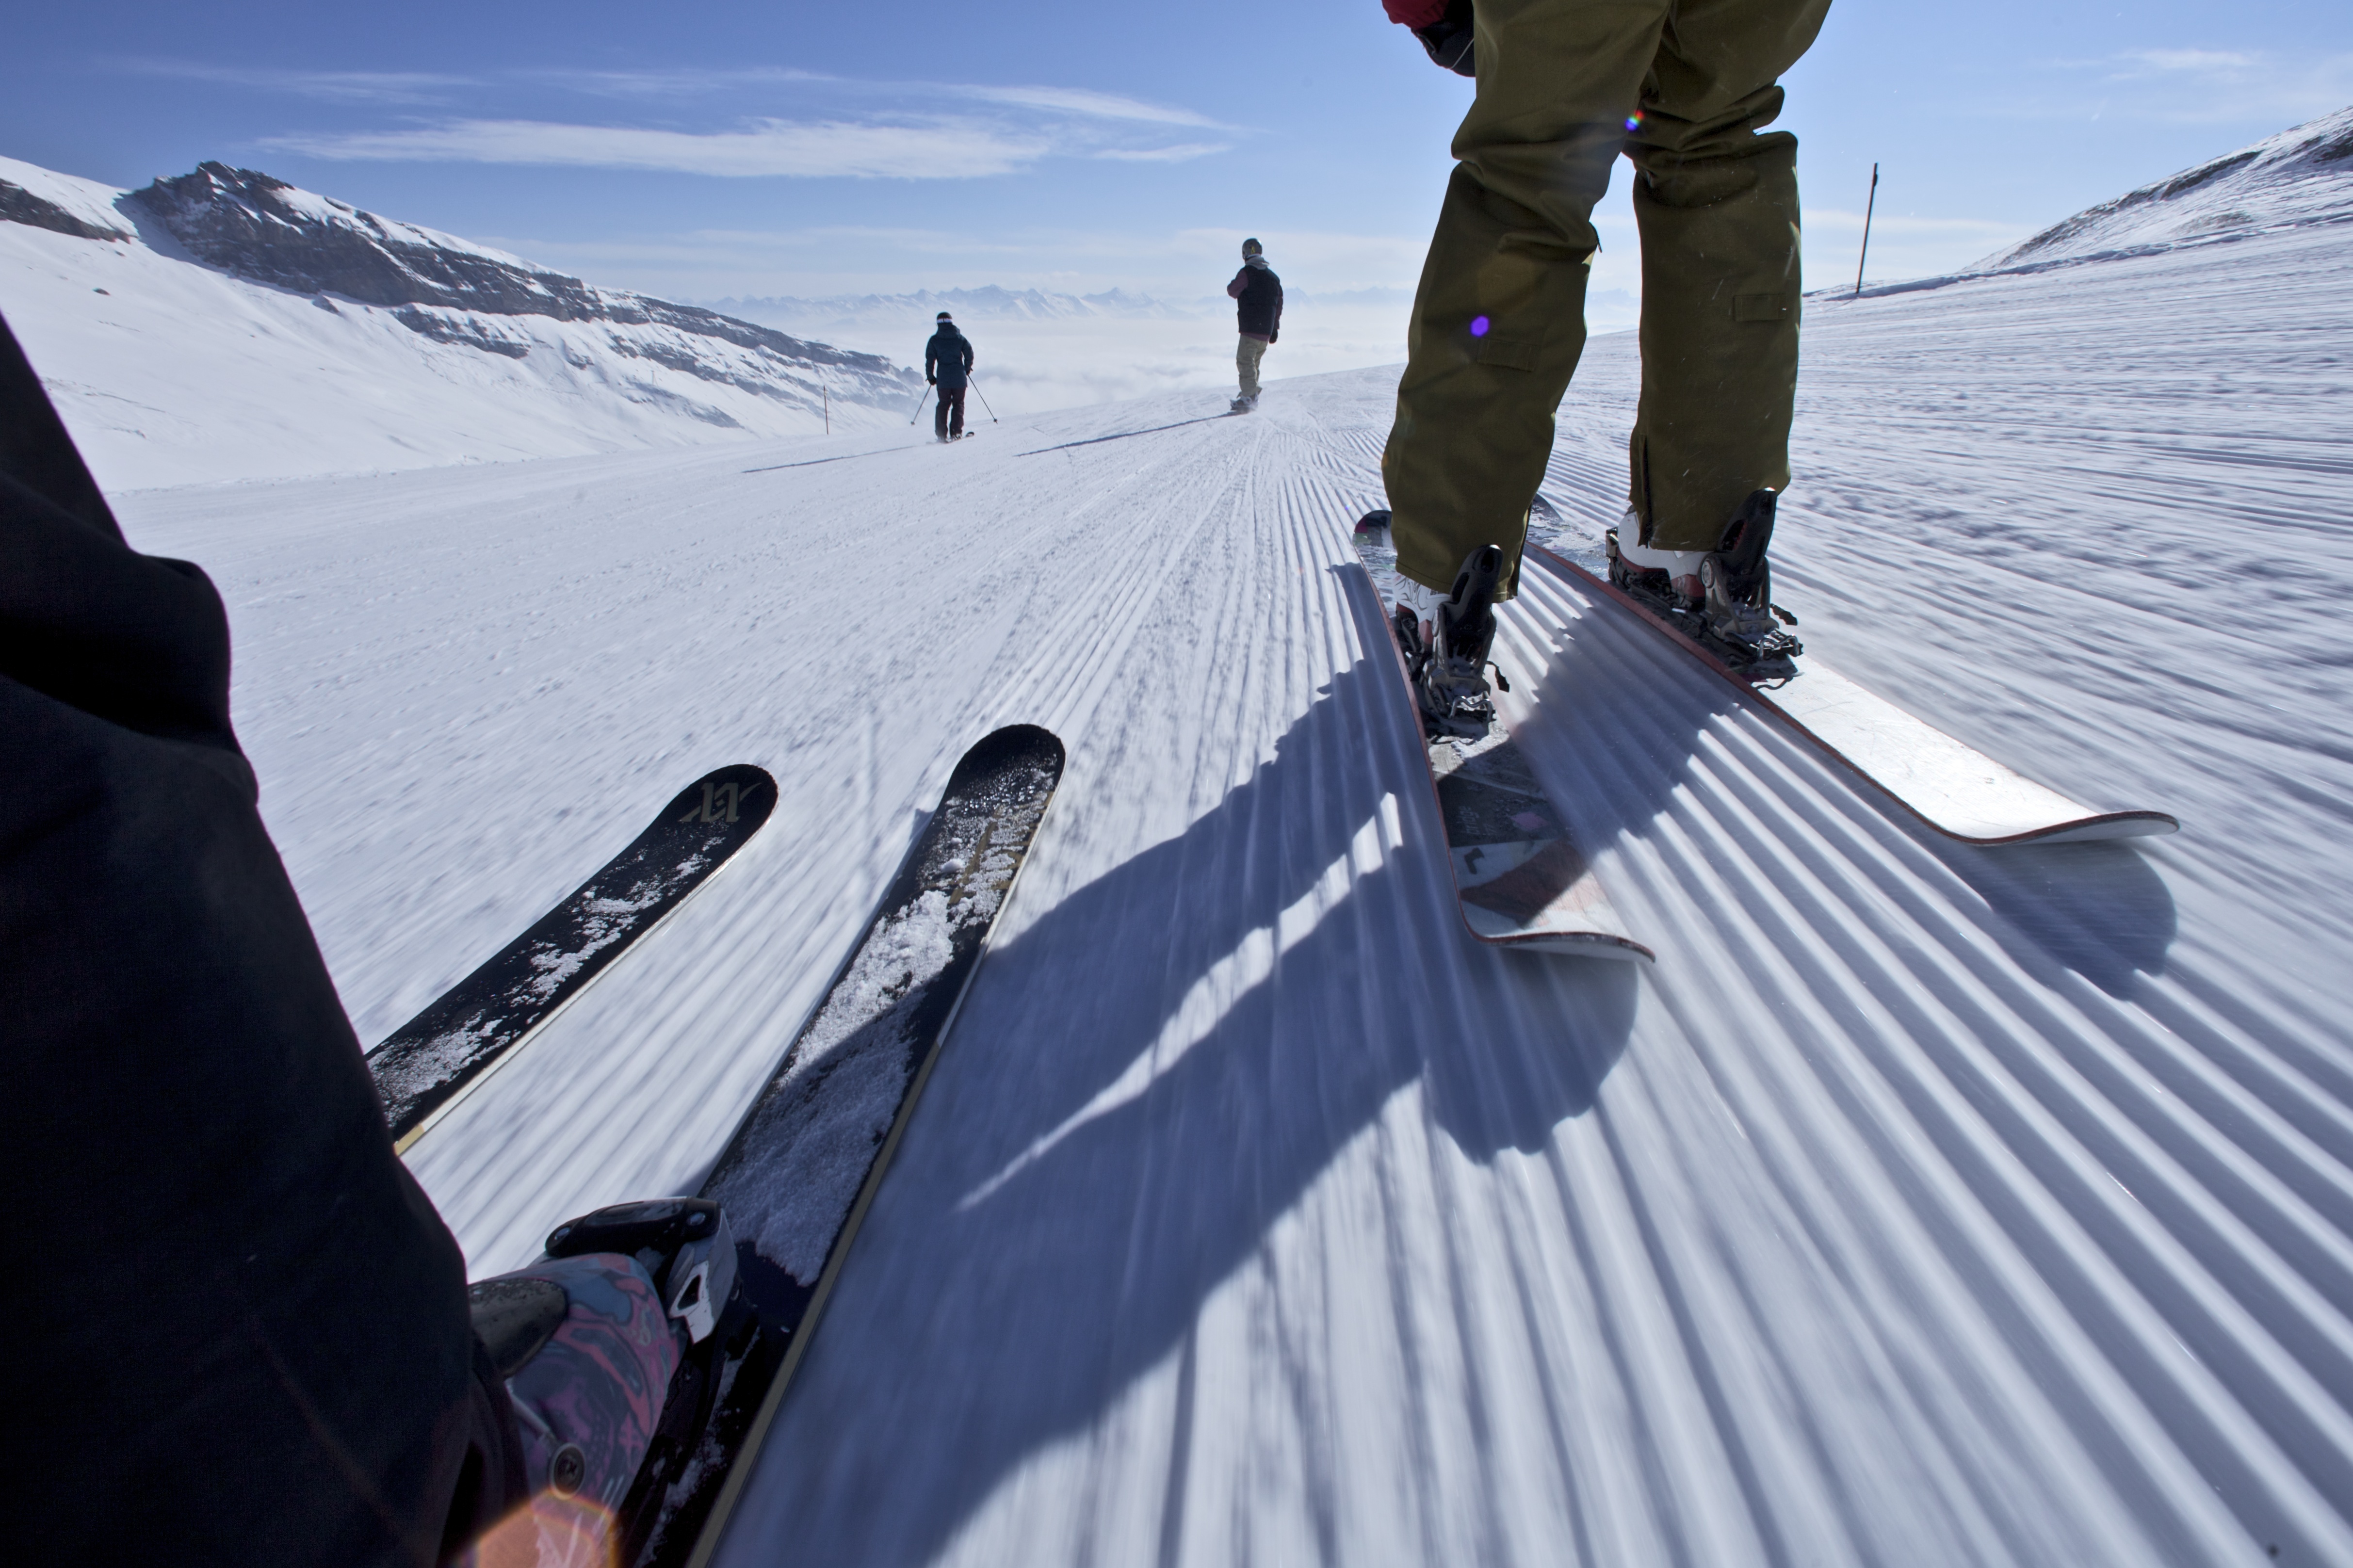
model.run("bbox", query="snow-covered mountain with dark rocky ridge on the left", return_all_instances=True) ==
[0,158,923,490]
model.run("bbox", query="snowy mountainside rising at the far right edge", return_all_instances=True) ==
[1967,108,2353,273]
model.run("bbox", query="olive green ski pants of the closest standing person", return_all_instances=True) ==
[1381,0,1831,598]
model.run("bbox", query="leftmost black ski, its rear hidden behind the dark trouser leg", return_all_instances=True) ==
[367,763,777,1154]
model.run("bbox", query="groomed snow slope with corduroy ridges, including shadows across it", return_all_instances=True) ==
[125,231,2353,1568]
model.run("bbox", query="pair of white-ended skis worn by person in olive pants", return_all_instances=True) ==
[1355,511,2181,961]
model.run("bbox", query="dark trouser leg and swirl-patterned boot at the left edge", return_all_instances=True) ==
[0,308,734,1568]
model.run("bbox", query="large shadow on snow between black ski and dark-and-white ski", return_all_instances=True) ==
[732,645,1640,1563]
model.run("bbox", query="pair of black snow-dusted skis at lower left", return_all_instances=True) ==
[370,725,1064,1568]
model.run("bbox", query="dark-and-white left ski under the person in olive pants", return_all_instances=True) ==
[1353,511,1654,963]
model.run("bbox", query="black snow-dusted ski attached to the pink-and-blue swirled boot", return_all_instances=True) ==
[638,725,1064,1568]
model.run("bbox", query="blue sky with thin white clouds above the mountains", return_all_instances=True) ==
[0,0,2353,299]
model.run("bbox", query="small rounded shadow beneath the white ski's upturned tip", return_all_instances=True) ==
[1932,841,2176,1001]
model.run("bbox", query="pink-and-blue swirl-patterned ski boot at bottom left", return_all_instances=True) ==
[466,1198,758,1563]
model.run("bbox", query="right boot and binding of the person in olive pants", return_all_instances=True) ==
[1605,490,1805,680]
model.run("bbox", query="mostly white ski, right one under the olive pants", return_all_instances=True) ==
[1527,544,2181,845]
